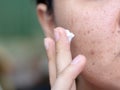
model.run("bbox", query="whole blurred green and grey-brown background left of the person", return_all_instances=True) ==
[0,0,47,90]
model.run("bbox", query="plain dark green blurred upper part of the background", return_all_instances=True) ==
[0,0,42,36]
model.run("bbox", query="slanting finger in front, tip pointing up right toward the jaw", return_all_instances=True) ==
[52,55,86,90]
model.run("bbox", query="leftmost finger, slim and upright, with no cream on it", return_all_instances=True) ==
[44,38,56,86]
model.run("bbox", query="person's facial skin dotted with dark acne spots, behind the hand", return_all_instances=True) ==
[37,0,120,90]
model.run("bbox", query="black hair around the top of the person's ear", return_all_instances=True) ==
[36,0,53,13]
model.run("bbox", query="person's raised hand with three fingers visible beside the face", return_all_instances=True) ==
[44,27,86,90]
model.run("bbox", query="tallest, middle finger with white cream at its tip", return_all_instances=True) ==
[55,27,72,74]
